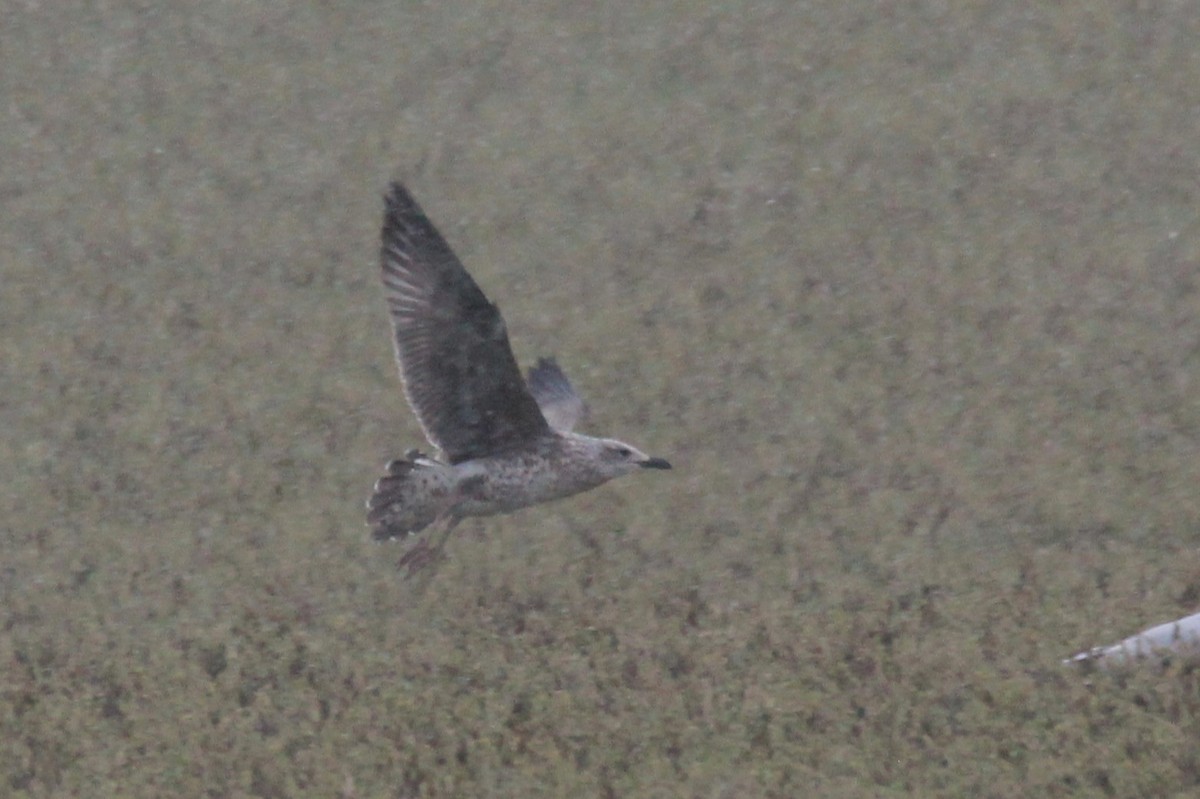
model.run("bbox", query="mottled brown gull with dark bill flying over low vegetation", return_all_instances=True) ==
[367,182,671,573]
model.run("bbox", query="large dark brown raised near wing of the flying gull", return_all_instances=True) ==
[382,184,550,463]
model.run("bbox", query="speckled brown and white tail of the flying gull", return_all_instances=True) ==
[367,451,455,541]
